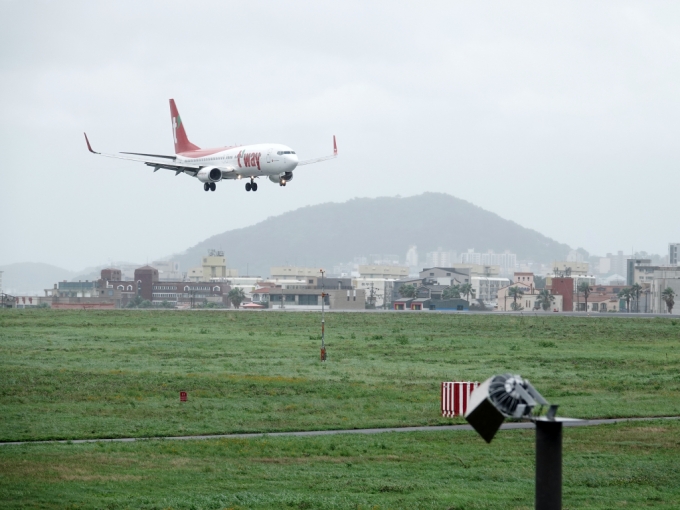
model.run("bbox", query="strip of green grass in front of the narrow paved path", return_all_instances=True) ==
[0,421,680,510]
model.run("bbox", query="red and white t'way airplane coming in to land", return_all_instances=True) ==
[83,99,338,191]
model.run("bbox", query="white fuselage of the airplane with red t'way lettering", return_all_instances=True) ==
[176,143,298,178]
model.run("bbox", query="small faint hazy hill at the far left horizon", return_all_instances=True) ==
[0,262,75,296]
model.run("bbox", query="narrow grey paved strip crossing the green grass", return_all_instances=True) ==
[0,416,680,446]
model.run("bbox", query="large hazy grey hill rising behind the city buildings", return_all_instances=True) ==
[174,193,570,276]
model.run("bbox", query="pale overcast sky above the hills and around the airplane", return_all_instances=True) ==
[0,0,680,270]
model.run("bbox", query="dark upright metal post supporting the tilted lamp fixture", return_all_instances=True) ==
[535,421,562,510]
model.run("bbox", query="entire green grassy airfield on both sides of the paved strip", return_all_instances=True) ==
[0,310,680,508]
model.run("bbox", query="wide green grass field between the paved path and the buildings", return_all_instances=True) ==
[0,310,680,441]
